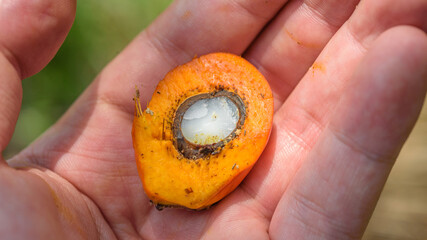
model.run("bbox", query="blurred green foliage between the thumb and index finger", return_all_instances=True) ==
[4,0,171,159]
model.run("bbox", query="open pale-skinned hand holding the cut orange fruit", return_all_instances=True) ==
[0,0,427,239]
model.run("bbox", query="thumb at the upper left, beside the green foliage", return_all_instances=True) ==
[0,0,76,152]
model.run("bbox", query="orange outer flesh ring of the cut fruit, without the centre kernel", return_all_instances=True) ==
[132,53,273,209]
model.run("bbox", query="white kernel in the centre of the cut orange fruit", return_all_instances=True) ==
[181,96,239,145]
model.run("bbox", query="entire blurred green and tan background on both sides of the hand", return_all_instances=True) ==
[4,0,427,240]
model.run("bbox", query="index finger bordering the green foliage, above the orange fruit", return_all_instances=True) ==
[88,0,286,112]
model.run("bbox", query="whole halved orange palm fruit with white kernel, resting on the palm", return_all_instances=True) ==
[132,53,273,210]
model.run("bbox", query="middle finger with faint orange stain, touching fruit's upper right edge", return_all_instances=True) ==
[245,0,359,110]
